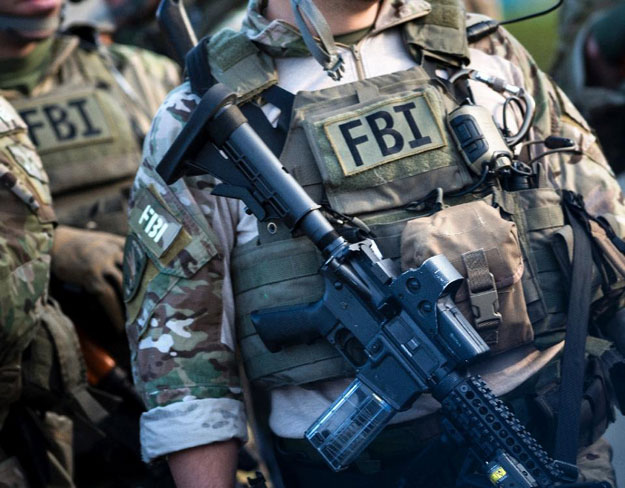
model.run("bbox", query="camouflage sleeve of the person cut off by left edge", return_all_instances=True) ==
[0,99,55,424]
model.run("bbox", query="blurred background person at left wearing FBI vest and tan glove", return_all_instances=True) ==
[0,0,179,487]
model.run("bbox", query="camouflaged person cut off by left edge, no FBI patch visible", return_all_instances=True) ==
[0,97,71,488]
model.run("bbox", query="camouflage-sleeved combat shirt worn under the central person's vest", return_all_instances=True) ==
[125,1,625,486]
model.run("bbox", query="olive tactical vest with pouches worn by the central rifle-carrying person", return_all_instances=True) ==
[201,2,622,388]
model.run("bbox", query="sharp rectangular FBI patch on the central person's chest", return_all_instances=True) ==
[323,93,445,176]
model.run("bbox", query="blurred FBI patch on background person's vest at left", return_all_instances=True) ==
[15,89,113,154]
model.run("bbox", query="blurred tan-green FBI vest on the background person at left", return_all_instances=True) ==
[7,37,145,235]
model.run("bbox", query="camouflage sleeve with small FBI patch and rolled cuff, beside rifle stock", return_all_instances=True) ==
[124,84,247,459]
